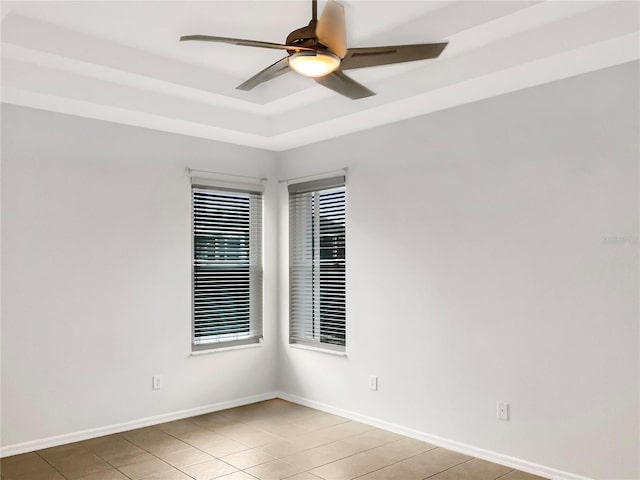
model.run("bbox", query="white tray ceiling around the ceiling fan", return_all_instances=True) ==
[1,0,640,150]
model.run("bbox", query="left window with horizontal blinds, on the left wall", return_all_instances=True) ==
[191,179,262,350]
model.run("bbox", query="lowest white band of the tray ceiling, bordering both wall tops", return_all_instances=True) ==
[2,33,640,151]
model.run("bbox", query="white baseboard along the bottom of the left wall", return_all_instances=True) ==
[0,392,278,458]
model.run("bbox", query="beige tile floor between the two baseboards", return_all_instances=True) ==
[0,399,541,480]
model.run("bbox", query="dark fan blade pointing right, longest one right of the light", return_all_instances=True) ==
[340,43,447,70]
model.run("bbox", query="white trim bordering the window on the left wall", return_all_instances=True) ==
[189,177,264,355]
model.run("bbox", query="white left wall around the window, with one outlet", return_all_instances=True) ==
[1,105,277,446]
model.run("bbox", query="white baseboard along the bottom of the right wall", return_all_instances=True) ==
[277,392,592,480]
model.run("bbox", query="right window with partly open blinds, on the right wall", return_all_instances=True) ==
[289,177,346,351]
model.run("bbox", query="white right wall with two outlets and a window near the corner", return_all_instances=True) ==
[280,62,640,479]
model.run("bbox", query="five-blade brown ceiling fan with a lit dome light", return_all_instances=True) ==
[180,0,447,100]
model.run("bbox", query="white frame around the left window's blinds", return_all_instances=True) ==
[190,177,264,354]
